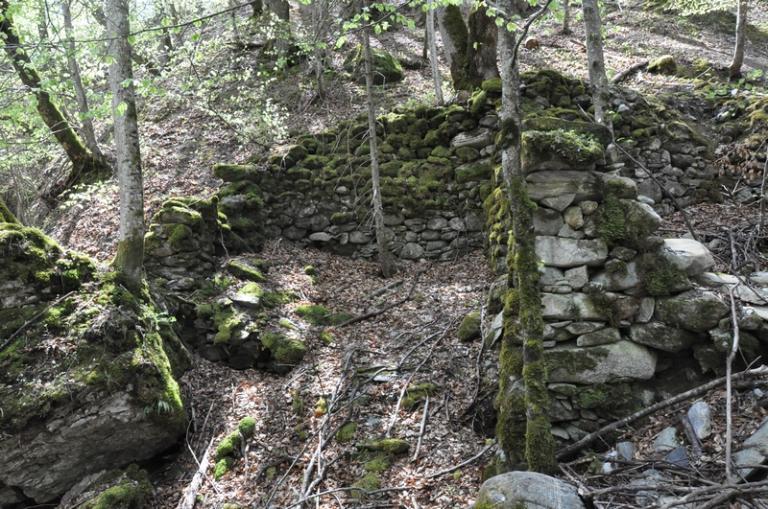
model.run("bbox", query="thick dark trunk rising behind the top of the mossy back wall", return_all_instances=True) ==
[467,7,499,83]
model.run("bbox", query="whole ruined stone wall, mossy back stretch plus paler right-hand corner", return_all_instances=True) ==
[142,72,768,440]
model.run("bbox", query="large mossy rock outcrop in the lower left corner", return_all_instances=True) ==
[0,227,187,507]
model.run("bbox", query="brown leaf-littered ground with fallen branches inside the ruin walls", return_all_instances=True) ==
[151,242,495,508]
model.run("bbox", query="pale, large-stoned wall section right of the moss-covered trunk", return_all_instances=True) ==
[485,130,768,441]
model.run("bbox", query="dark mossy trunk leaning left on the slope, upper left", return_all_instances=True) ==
[0,0,110,198]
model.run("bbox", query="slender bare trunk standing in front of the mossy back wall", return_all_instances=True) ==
[363,14,395,277]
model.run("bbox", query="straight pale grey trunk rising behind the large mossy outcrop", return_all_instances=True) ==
[106,0,144,292]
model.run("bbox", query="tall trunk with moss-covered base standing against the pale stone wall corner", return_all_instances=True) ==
[497,0,555,472]
